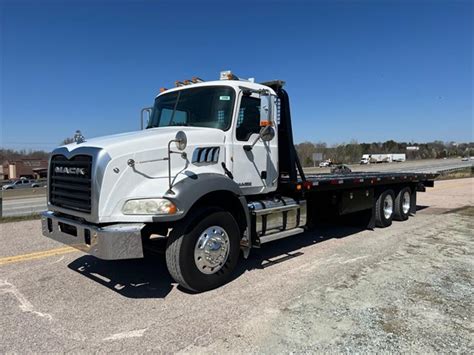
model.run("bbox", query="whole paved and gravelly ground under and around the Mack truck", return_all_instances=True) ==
[0,178,474,353]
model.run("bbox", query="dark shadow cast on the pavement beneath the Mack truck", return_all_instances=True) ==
[68,226,363,298]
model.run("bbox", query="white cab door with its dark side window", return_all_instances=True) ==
[231,93,278,195]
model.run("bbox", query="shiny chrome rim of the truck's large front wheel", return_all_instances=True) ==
[194,226,230,275]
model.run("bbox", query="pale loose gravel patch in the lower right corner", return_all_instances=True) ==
[254,213,474,353]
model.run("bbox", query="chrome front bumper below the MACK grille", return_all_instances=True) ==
[41,211,145,260]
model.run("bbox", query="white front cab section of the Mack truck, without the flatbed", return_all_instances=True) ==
[43,72,303,289]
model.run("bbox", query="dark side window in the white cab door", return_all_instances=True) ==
[236,96,260,141]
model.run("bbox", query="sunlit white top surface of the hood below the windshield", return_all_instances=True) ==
[64,126,225,157]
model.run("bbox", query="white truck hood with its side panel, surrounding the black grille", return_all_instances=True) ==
[52,126,229,223]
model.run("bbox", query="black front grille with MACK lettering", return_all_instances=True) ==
[49,155,92,213]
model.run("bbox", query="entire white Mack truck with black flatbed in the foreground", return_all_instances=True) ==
[42,71,436,292]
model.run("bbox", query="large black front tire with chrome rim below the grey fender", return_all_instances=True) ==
[166,209,240,292]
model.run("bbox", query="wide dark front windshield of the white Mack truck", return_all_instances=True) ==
[147,86,235,131]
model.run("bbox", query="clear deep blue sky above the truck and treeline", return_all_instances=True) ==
[0,0,474,150]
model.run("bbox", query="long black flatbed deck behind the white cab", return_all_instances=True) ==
[280,172,439,191]
